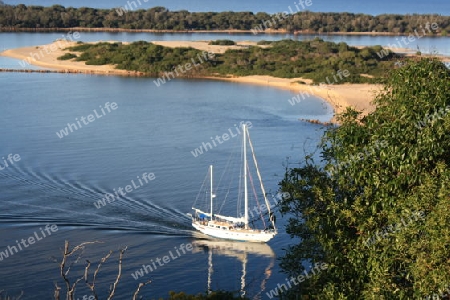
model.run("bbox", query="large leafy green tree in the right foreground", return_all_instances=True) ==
[281,59,450,300]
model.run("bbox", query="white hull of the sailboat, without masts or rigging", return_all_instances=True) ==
[192,221,276,243]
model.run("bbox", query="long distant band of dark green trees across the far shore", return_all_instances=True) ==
[0,1,450,35]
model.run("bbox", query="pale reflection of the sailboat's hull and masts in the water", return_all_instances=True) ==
[192,238,276,299]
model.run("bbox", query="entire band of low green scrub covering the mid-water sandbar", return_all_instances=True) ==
[64,39,394,84]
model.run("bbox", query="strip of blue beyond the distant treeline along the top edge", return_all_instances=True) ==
[4,0,450,16]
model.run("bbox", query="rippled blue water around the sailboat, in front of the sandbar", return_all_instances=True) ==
[0,34,332,299]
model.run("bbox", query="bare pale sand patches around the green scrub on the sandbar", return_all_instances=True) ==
[0,41,381,122]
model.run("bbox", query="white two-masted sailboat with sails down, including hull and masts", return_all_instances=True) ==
[192,124,277,243]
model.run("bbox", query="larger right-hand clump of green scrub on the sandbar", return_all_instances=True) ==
[207,39,393,83]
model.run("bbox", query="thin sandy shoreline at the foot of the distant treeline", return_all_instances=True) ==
[0,27,450,37]
